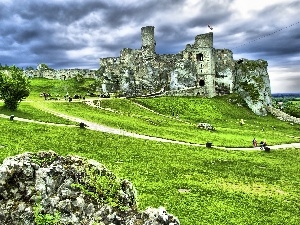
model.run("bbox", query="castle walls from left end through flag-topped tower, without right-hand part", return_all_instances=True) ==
[100,27,219,97]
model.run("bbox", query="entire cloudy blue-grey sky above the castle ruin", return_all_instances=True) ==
[0,0,300,93]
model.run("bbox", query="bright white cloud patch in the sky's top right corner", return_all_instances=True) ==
[218,1,300,46]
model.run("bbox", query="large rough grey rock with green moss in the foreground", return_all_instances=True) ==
[0,151,180,225]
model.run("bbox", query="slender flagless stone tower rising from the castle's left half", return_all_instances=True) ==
[141,26,156,57]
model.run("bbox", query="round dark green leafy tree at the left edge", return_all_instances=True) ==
[0,66,30,111]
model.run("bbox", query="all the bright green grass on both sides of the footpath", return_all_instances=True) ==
[0,79,300,225]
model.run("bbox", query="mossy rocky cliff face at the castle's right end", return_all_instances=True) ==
[234,59,272,116]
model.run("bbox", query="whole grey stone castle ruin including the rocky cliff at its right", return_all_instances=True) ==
[100,26,272,115]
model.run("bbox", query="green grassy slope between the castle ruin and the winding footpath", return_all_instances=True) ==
[31,92,300,147]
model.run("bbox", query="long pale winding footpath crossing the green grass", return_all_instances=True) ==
[0,102,300,151]
